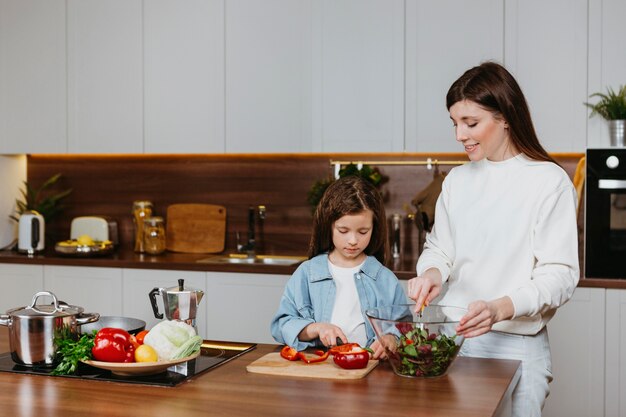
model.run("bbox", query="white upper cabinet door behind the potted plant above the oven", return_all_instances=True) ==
[585,0,626,148]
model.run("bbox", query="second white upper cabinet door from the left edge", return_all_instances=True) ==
[67,0,143,153]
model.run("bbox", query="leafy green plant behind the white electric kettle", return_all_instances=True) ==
[9,173,72,223]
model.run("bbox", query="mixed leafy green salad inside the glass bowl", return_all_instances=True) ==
[393,327,459,377]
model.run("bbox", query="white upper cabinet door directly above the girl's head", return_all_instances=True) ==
[312,0,405,152]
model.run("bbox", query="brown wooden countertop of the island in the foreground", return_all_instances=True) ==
[0,328,520,417]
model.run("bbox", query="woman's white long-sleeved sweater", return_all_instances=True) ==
[417,154,580,335]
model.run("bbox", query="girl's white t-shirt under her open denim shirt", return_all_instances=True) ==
[328,260,367,346]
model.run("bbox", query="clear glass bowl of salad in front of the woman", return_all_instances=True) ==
[365,304,467,378]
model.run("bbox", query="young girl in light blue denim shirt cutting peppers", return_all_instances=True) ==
[271,176,407,358]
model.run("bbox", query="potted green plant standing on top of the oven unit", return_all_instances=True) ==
[585,85,626,146]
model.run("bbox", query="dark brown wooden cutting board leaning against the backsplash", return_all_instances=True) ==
[166,204,226,253]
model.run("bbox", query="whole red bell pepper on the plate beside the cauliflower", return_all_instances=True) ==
[91,327,138,362]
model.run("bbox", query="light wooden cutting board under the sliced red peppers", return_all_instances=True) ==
[246,352,378,379]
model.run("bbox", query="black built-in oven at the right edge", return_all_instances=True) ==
[585,148,626,278]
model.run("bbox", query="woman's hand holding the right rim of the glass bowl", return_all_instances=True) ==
[456,297,515,337]
